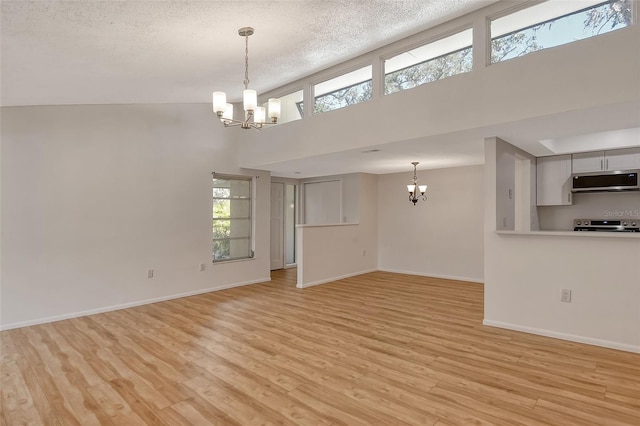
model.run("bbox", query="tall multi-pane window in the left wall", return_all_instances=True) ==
[213,173,253,262]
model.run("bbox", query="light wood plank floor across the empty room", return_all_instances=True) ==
[0,270,640,426]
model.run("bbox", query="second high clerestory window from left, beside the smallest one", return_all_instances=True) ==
[313,65,372,114]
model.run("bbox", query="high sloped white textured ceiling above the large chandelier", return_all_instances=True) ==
[1,0,494,106]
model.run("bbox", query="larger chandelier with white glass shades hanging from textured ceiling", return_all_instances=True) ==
[213,27,280,130]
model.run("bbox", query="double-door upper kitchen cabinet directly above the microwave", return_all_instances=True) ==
[572,147,640,173]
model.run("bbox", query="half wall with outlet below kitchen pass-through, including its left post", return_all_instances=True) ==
[484,138,640,352]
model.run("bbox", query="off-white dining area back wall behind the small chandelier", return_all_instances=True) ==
[378,166,484,281]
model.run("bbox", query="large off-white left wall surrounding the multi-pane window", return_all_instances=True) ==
[0,105,270,328]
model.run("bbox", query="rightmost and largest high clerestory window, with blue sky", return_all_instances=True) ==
[491,0,633,63]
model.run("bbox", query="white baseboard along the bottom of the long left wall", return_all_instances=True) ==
[0,277,271,331]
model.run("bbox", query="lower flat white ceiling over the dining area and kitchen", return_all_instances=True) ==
[251,102,640,179]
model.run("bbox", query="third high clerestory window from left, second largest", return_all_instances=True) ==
[384,29,473,95]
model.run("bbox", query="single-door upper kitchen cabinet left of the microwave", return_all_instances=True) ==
[536,154,572,206]
